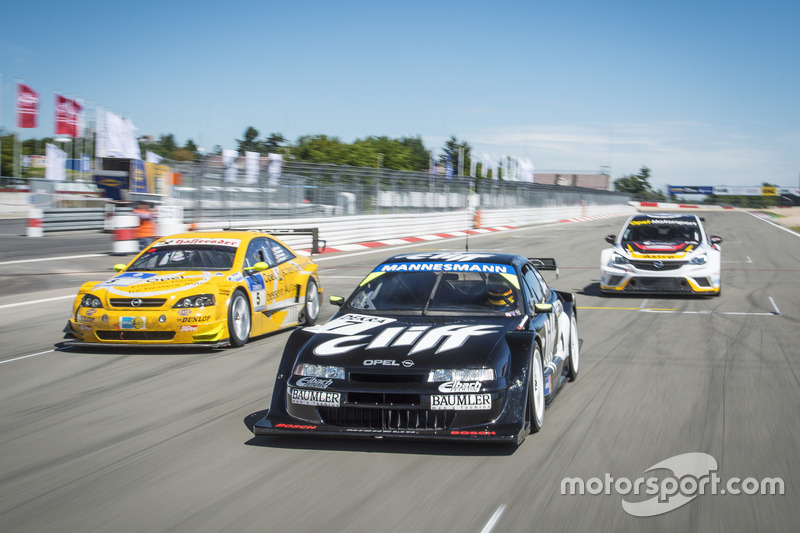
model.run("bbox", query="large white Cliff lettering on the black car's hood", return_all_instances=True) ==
[314,322,502,356]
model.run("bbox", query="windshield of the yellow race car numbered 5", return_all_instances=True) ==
[127,246,236,272]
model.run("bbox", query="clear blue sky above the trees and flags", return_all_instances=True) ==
[0,0,800,187]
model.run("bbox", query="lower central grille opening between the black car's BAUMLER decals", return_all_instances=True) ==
[319,407,456,431]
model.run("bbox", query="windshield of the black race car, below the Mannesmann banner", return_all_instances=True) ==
[348,272,521,315]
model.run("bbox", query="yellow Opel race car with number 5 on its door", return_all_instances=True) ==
[64,231,322,347]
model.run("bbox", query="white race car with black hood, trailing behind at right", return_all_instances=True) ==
[600,213,722,296]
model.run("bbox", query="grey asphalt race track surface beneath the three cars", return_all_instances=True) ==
[0,212,800,532]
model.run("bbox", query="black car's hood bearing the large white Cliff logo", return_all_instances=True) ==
[298,313,522,369]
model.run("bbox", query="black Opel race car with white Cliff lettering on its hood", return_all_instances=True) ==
[253,252,579,444]
